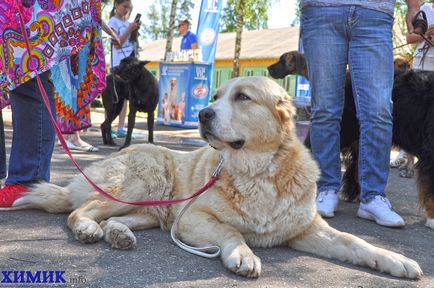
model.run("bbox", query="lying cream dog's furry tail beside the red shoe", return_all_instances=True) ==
[0,183,72,213]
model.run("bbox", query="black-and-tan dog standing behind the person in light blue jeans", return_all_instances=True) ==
[269,51,434,229]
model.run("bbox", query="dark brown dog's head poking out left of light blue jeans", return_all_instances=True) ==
[267,51,307,79]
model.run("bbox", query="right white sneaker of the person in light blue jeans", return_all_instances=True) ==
[357,195,405,227]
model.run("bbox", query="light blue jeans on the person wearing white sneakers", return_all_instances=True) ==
[301,5,393,203]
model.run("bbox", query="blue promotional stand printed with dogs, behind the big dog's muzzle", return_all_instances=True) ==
[157,62,211,128]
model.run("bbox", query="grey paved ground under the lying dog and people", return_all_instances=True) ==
[0,110,434,288]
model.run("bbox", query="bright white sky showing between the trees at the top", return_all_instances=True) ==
[125,0,296,31]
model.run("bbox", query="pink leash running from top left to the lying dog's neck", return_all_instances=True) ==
[15,0,223,206]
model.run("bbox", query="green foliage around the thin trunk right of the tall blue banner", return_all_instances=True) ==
[220,0,272,32]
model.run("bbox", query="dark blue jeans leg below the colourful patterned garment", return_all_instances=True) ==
[6,71,56,185]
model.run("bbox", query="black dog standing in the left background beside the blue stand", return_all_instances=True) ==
[101,57,158,149]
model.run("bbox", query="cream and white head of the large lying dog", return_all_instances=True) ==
[199,77,296,153]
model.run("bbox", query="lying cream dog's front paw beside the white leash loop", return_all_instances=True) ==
[222,244,261,277]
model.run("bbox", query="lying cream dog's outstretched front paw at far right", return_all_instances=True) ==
[369,249,423,279]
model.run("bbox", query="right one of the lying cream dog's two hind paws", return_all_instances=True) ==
[101,221,137,250]
